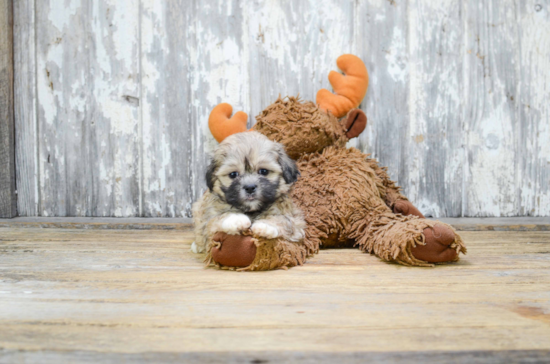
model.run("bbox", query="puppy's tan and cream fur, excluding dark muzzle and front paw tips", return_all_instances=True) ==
[193,132,305,258]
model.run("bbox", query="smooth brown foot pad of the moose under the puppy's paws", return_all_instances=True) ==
[211,232,256,268]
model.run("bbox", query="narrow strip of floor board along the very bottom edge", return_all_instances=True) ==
[0,350,550,364]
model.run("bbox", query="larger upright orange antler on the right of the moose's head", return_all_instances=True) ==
[317,54,369,118]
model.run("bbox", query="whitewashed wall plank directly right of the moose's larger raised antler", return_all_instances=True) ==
[354,0,412,185]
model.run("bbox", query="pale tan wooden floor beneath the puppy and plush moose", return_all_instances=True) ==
[0,227,550,363]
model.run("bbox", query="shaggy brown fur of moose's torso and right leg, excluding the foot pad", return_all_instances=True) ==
[293,147,466,266]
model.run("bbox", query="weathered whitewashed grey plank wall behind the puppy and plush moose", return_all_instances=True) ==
[14,0,550,217]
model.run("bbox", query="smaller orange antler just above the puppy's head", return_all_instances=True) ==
[208,103,248,143]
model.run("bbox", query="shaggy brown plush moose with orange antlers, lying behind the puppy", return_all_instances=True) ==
[207,55,466,270]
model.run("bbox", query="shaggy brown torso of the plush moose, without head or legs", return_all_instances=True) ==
[292,147,391,247]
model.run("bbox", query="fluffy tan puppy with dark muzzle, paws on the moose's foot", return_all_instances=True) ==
[192,131,305,253]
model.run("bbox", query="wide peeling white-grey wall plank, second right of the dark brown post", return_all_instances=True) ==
[36,0,139,216]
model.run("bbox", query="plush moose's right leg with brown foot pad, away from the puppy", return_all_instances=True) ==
[350,213,466,266]
